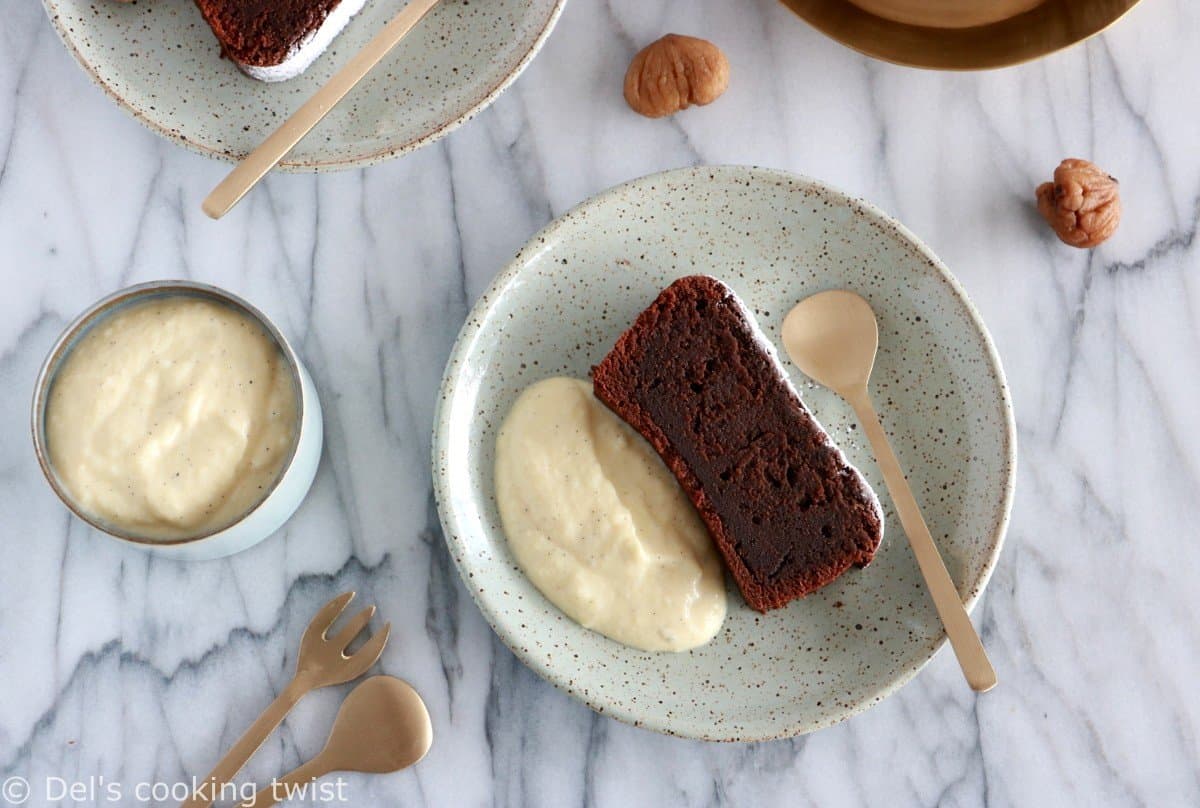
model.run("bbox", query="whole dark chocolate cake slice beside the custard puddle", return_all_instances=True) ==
[593,275,883,612]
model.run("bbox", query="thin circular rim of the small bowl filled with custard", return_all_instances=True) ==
[30,281,305,547]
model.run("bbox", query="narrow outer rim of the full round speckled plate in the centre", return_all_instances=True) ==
[432,166,1016,742]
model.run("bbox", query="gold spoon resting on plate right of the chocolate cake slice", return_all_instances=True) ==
[784,289,996,692]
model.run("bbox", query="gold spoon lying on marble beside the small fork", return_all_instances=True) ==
[241,676,433,808]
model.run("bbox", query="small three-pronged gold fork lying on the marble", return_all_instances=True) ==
[181,592,391,808]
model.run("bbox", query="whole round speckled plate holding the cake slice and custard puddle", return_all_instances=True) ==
[433,167,1015,741]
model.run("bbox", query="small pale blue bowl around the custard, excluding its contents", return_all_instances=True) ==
[32,281,324,561]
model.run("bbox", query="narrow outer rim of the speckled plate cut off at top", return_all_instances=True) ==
[42,0,566,173]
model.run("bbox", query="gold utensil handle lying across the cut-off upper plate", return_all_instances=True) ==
[200,0,439,219]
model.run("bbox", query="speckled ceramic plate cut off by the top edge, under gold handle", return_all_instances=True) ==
[43,0,566,170]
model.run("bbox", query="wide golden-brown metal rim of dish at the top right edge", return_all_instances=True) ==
[780,0,1140,71]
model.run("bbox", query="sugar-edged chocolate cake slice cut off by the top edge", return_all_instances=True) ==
[196,0,365,82]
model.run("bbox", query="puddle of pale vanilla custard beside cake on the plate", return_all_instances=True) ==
[496,378,726,651]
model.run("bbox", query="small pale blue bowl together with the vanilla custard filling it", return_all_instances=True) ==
[34,282,322,558]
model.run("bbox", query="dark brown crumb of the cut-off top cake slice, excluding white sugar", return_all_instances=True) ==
[196,0,341,67]
